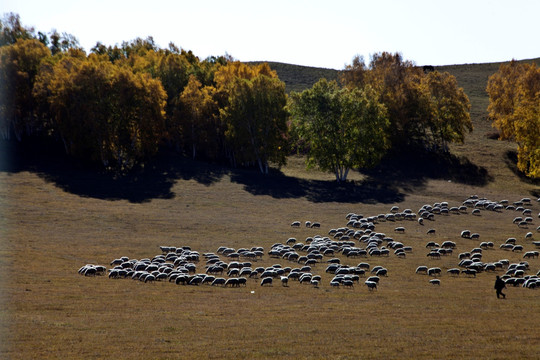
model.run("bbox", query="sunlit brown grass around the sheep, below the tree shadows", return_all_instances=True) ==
[1,159,540,359]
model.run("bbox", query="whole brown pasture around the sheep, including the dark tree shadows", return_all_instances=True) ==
[0,57,540,359]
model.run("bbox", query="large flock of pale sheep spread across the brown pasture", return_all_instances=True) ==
[78,196,540,291]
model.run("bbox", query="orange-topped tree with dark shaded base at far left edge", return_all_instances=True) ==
[0,39,51,140]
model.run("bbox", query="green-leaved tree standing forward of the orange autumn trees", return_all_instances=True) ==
[291,79,389,182]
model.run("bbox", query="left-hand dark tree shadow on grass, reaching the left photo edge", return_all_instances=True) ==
[0,141,227,203]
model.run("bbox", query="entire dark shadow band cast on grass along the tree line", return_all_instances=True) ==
[0,142,493,204]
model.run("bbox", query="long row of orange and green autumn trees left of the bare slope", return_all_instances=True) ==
[0,14,536,181]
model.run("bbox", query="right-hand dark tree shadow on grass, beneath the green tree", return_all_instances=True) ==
[231,149,493,204]
